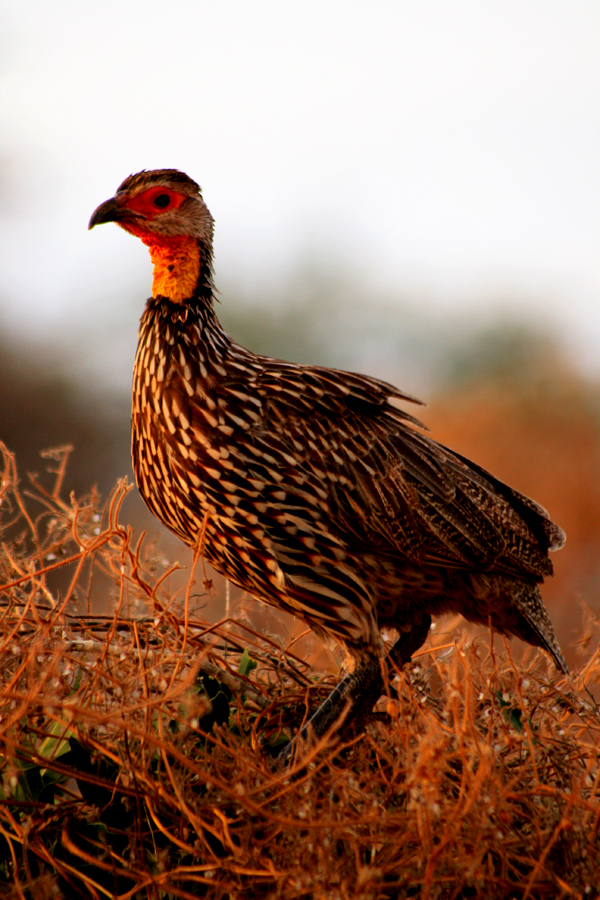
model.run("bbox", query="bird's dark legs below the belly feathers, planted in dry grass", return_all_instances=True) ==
[278,615,431,764]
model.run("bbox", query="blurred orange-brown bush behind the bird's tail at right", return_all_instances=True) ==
[422,332,600,646]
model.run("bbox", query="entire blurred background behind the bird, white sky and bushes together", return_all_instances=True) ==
[0,0,600,668]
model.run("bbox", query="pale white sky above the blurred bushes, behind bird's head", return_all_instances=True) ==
[0,0,600,374]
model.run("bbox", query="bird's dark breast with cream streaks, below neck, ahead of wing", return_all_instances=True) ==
[132,317,264,543]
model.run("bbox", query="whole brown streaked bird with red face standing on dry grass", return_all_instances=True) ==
[89,169,568,752]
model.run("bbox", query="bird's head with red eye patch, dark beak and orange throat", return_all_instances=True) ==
[88,169,213,303]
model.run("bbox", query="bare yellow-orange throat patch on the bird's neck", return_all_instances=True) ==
[142,234,200,303]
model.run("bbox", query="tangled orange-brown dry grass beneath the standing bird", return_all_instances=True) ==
[0,444,600,900]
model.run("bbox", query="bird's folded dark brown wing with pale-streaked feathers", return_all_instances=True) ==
[227,358,564,580]
